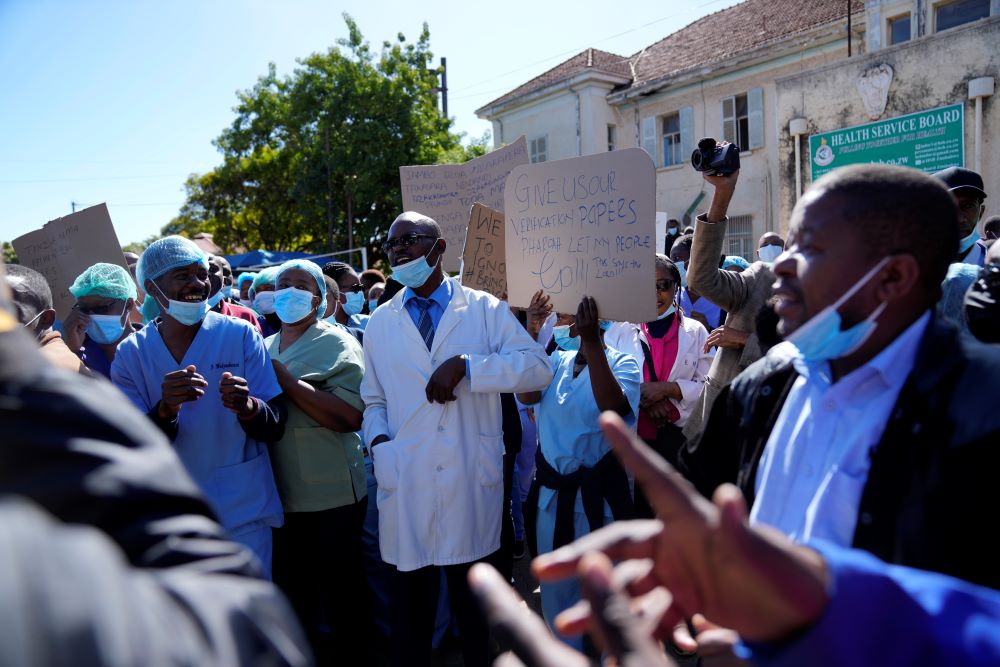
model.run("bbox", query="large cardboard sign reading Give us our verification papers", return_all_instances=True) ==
[504,148,657,322]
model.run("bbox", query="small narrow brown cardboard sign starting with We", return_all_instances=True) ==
[462,203,507,298]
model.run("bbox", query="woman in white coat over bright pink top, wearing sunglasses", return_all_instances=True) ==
[606,255,712,517]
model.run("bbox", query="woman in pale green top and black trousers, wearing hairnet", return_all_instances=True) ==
[265,259,373,665]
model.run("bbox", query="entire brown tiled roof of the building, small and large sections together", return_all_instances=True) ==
[482,0,864,109]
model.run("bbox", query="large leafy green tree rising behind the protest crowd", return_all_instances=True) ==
[175,14,464,259]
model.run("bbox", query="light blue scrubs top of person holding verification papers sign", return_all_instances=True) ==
[535,347,642,512]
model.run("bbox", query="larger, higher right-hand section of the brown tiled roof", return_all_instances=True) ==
[630,0,864,86]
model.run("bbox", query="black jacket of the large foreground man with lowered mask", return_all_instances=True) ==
[680,319,1000,588]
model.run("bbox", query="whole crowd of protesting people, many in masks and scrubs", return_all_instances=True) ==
[0,154,1000,667]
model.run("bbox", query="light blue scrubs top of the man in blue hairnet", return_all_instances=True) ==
[111,311,284,533]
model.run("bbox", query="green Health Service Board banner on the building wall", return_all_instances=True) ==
[809,104,965,180]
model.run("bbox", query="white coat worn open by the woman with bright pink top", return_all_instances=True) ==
[604,317,715,428]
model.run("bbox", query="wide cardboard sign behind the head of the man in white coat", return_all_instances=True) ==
[399,137,528,272]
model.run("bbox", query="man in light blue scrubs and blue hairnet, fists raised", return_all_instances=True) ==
[111,236,286,575]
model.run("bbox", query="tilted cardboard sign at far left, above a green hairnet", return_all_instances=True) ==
[11,204,128,319]
